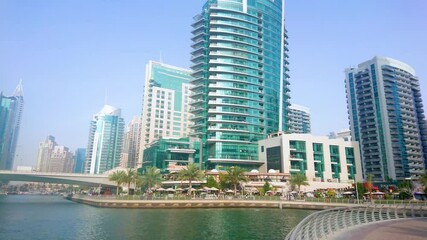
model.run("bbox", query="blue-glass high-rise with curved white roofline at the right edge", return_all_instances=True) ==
[345,57,427,181]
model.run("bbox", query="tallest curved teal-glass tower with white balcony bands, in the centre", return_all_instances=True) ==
[191,0,290,169]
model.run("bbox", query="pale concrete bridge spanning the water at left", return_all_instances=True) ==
[0,171,116,187]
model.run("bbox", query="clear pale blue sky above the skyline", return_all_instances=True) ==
[0,0,427,169]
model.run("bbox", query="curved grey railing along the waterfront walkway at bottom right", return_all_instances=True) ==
[285,205,427,240]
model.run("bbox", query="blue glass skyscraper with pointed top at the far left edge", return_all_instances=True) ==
[0,83,24,170]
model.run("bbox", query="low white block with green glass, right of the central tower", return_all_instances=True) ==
[258,132,362,188]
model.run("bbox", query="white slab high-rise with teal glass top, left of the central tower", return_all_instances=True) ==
[138,61,192,166]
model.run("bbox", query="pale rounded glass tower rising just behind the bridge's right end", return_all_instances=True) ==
[85,105,124,174]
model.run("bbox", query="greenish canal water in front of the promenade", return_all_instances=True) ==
[0,195,313,240]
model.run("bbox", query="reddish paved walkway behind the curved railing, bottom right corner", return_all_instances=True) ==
[330,218,427,240]
